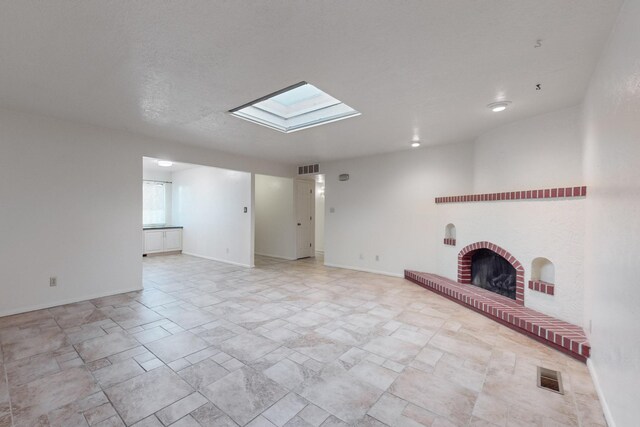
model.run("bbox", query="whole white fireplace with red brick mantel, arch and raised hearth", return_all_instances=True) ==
[405,186,590,361]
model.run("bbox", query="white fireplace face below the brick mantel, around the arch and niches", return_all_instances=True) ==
[431,199,585,325]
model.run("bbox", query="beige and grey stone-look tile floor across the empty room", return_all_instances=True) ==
[0,255,605,427]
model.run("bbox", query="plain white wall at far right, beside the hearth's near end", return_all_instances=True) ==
[583,1,640,427]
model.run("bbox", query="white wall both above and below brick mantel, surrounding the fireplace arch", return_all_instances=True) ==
[435,107,586,325]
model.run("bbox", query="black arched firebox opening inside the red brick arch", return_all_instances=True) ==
[471,249,516,300]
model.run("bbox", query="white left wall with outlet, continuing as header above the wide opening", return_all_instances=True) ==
[0,110,294,316]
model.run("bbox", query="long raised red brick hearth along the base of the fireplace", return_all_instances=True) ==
[404,270,591,361]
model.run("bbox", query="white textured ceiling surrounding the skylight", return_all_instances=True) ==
[0,0,622,164]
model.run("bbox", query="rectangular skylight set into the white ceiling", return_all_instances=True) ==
[229,82,360,133]
